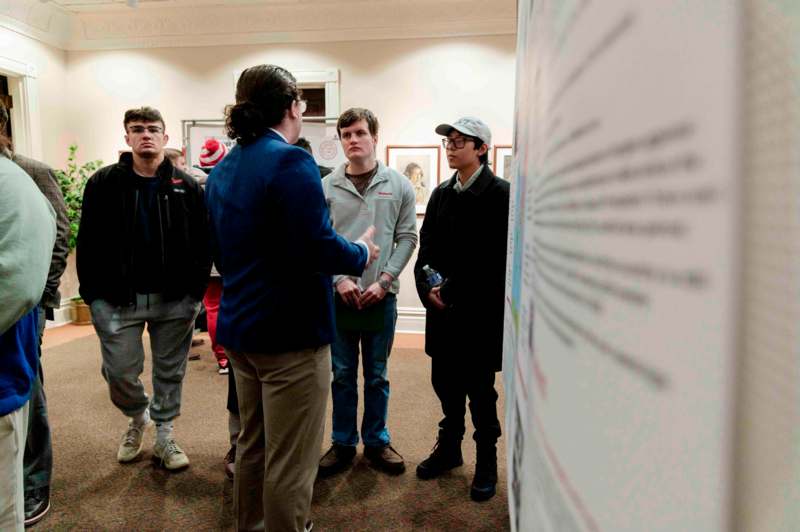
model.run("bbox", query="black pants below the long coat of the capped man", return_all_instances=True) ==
[431,356,501,447]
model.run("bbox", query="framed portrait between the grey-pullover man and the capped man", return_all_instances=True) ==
[386,145,441,214]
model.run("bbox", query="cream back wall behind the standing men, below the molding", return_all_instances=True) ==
[65,35,516,318]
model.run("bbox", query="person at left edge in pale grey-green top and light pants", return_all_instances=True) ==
[0,131,56,532]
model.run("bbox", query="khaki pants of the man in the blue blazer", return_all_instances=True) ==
[227,345,331,532]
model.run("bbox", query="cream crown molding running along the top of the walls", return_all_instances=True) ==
[0,0,516,50]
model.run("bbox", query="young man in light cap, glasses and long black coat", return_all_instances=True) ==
[414,117,509,501]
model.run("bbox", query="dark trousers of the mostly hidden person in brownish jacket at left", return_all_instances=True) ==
[23,305,53,493]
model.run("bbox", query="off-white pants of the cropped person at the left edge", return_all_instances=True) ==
[0,402,29,532]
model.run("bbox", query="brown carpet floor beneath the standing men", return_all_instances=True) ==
[35,330,509,531]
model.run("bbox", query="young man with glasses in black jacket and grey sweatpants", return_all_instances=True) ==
[77,107,211,470]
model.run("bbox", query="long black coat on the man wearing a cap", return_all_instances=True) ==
[414,166,509,371]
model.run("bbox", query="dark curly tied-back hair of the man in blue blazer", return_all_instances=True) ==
[225,65,302,145]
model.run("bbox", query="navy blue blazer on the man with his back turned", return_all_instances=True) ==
[206,131,367,353]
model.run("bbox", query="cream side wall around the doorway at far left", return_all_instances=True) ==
[0,28,67,166]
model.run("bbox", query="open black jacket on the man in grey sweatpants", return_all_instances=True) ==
[76,153,211,306]
